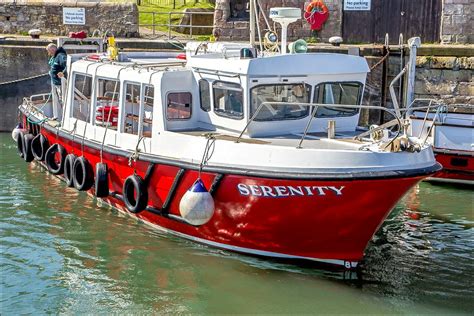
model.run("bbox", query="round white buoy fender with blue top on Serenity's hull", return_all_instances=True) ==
[179,179,214,226]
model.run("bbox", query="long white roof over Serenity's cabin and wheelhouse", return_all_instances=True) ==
[72,53,370,78]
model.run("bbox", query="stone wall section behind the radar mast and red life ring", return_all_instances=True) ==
[214,0,342,41]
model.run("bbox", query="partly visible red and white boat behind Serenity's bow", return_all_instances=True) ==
[407,99,474,186]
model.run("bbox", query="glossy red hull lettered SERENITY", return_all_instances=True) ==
[27,123,433,267]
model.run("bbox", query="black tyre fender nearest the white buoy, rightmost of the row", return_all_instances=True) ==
[123,174,148,213]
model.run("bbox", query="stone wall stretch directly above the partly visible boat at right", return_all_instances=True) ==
[415,56,474,106]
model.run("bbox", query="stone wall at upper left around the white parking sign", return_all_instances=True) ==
[0,0,138,37]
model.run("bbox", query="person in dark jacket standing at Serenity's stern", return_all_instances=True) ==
[46,43,67,120]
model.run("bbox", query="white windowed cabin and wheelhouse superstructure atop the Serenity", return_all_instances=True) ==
[64,49,368,150]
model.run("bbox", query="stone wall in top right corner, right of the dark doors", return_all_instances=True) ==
[441,0,474,44]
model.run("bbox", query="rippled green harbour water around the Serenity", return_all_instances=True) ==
[0,134,474,315]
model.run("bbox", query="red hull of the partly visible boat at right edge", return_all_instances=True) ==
[429,148,474,185]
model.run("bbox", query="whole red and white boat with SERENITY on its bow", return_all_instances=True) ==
[14,10,441,269]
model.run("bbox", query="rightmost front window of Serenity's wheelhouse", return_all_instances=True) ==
[313,82,362,117]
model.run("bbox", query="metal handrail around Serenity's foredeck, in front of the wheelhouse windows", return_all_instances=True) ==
[235,101,402,148]
